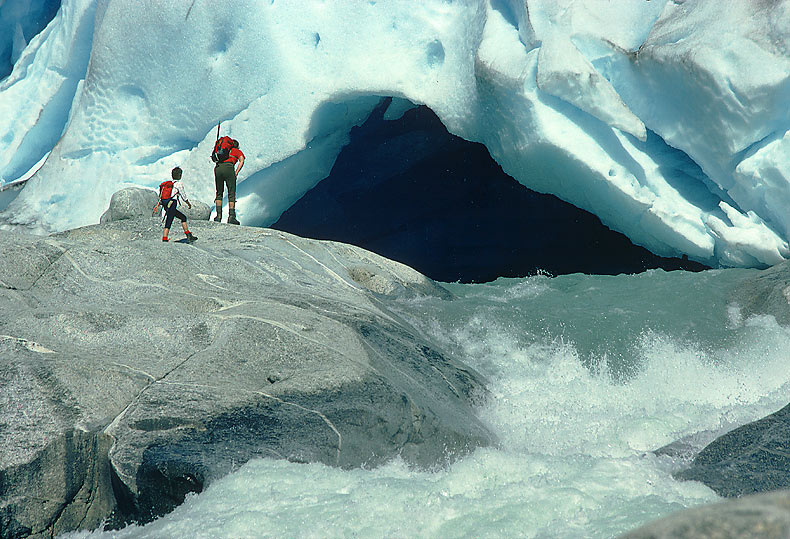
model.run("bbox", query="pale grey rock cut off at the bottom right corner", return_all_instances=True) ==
[620,491,790,539]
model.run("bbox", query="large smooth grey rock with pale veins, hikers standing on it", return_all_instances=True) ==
[0,218,494,537]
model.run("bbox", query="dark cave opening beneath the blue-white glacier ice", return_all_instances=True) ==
[272,99,706,283]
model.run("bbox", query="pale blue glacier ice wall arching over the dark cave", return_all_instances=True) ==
[0,0,790,267]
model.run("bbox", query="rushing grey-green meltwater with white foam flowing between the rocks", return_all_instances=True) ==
[68,270,790,538]
